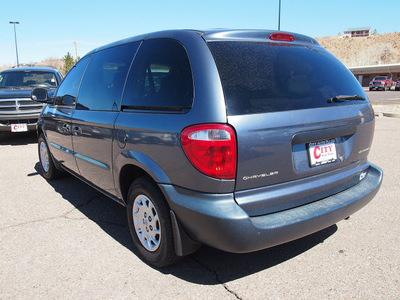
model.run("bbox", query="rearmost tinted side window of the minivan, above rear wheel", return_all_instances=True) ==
[122,39,193,110]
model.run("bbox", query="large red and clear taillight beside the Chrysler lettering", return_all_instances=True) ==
[181,124,237,179]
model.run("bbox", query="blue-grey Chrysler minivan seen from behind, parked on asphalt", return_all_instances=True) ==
[32,30,382,267]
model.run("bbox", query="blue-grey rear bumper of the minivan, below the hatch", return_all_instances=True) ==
[160,164,383,253]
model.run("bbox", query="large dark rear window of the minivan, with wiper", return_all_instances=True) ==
[208,42,366,115]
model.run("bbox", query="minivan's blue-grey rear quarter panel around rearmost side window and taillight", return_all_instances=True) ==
[113,31,235,197]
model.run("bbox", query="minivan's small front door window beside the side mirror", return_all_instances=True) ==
[56,56,90,105]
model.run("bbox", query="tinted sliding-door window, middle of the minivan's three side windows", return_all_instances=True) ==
[76,43,139,110]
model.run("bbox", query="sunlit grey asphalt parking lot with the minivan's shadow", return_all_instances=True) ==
[0,117,400,299]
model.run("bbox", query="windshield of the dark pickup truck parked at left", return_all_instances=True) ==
[0,71,57,87]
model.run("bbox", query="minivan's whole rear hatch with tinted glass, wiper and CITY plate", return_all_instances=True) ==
[208,40,374,216]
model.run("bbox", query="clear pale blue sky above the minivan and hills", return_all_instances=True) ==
[0,0,400,66]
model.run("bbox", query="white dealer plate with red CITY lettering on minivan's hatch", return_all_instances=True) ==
[308,139,337,167]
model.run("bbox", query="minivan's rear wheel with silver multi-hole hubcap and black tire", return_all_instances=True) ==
[127,178,178,267]
